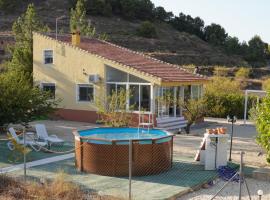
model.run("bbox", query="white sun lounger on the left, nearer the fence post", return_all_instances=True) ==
[7,127,47,151]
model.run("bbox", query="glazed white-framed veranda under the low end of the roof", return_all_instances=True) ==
[106,66,205,128]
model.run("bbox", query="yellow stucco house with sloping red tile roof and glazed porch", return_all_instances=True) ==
[33,33,207,128]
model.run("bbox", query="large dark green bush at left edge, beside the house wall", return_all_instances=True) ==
[0,71,59,127]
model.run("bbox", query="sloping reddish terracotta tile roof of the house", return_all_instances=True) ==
[51,35,207,82]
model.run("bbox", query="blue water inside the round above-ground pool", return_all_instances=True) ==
[79,128,171,144]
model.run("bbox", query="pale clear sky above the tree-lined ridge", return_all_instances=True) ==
[152,0,270,43]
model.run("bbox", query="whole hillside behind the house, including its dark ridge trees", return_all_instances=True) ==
[0,0,270,66]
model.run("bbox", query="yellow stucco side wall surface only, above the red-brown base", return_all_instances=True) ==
[33,34,105,111]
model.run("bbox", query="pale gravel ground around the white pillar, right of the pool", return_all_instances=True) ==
[174,118,270,167]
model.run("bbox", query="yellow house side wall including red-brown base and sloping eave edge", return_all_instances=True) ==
[33,33,207,122]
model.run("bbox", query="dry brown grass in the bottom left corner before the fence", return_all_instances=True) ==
[0,173,117,200]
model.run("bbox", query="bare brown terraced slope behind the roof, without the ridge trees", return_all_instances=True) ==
[0,0,244,66]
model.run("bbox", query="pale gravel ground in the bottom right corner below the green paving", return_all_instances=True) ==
[177,178,270,200]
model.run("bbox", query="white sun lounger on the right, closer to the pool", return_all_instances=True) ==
[35,124,64,146]
